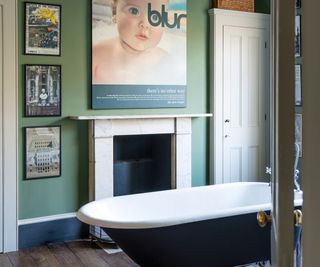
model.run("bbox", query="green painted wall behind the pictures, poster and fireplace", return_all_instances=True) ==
[18,0,268,219]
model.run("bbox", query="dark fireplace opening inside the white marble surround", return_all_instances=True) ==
[113,134,171,196]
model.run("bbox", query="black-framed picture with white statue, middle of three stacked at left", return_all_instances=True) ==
[25,65,61,117]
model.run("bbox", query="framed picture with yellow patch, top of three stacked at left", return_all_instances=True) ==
[25,2,61,56]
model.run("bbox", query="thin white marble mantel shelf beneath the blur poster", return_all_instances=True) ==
[69,113,212,120]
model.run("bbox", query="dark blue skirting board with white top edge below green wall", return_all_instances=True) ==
[18,213,89,249]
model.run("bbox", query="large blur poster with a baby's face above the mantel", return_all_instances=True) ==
[91,0,187,109]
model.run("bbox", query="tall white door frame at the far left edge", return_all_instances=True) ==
[0,0,18,252]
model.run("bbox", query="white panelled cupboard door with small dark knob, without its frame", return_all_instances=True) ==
[221,26,269,183]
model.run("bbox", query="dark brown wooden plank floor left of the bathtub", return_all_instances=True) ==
[0,240,139,267]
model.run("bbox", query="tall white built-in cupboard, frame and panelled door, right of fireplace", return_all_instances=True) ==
[209,9,270,184]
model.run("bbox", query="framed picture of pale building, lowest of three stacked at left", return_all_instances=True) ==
[24,126,61,179]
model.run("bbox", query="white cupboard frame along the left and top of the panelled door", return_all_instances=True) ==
[209,9,270,184]
